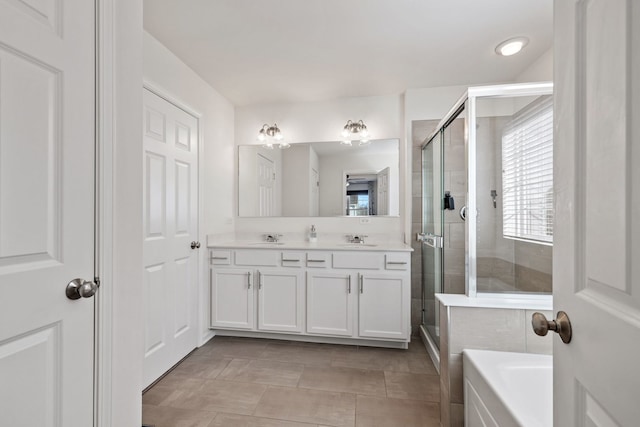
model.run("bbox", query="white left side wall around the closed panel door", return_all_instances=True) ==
[144,32,237,341]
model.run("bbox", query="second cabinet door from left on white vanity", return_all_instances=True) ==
[257,270,304,332]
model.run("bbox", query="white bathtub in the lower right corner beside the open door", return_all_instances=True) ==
[462,350,553,427]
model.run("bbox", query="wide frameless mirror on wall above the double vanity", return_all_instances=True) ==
[238,139,400,217]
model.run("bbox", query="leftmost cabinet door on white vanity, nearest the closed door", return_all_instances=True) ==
[211,268,255,329]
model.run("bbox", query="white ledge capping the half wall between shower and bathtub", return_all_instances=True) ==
[436,294,553,310]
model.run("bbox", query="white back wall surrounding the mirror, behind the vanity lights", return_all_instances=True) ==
[235,95,410,239]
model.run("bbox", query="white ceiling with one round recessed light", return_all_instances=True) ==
[144,0,553,106]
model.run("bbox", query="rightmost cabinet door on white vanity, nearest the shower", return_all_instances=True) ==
[358,274,410,339]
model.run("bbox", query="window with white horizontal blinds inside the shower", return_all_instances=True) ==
[502,95,553,244]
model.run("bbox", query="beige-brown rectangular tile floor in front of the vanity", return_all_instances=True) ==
[142,337,440,427]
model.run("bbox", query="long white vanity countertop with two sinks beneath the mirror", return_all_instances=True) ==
[207,239,413,252]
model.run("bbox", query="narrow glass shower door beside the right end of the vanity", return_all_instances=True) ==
[421,131,443,347]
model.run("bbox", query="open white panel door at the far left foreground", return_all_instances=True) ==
[0,0,95,427]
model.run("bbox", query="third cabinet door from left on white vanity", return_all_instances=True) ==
[307,271,356,337]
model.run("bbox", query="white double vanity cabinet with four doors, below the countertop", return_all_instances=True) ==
[210,248,411,348]
